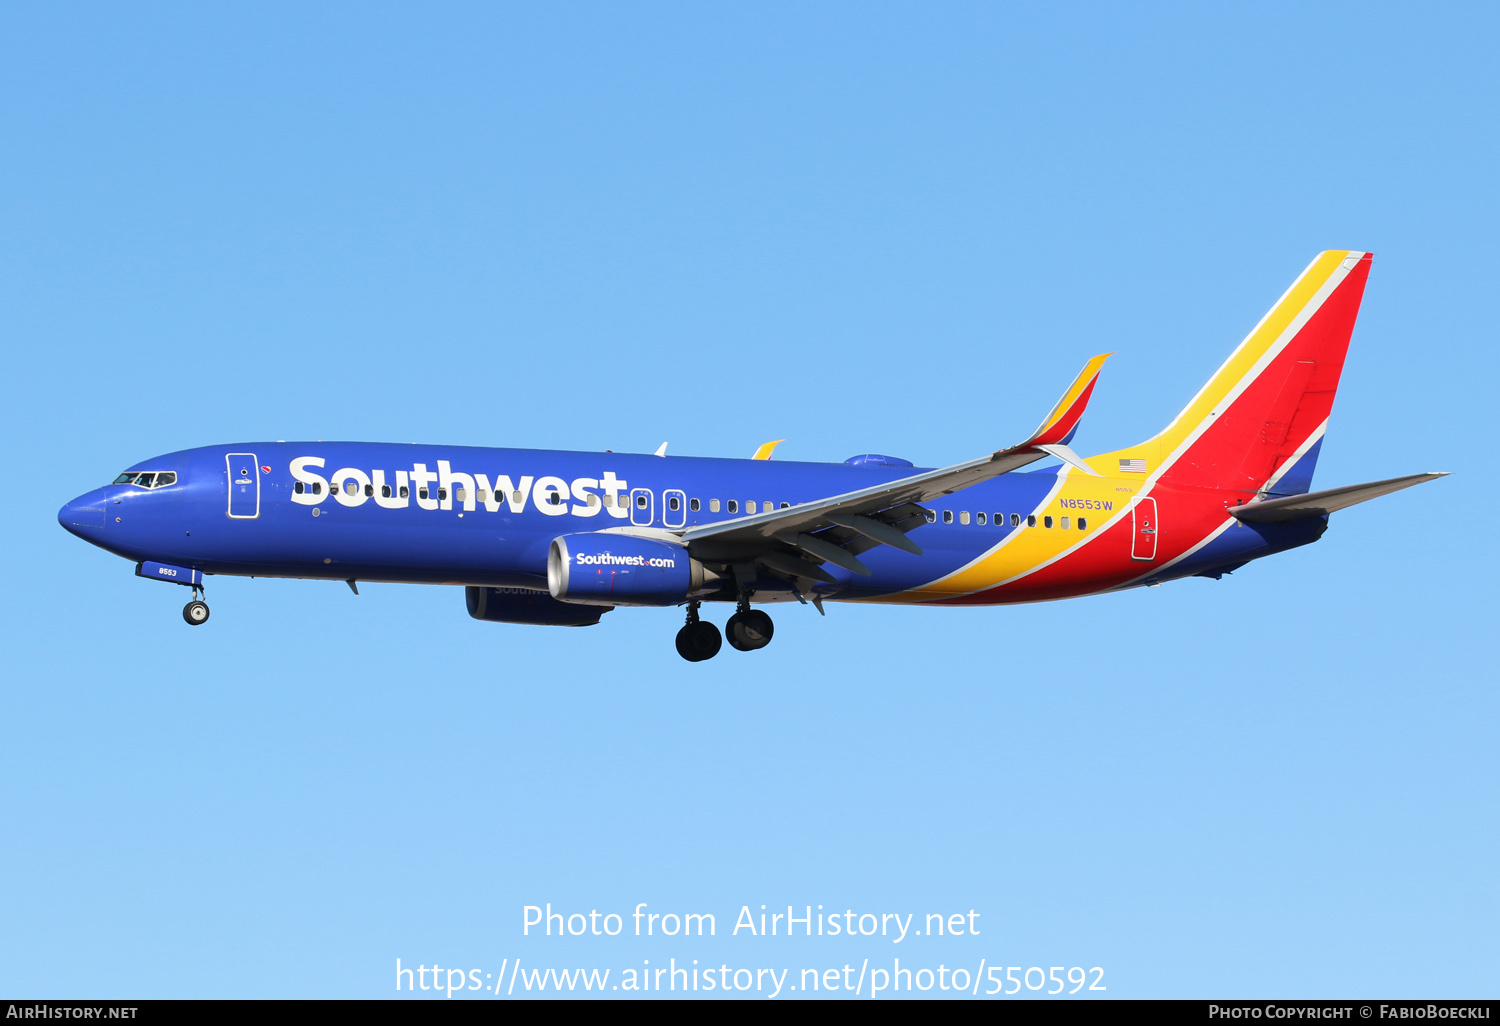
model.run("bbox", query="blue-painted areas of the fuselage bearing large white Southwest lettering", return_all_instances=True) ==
[59,443,1311,600]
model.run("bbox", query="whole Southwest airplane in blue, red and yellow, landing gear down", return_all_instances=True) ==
[59,251,1442,662]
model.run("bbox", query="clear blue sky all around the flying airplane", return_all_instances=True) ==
[0,3,1500,998]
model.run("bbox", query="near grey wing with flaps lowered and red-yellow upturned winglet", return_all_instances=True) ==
[681,353,1110,584]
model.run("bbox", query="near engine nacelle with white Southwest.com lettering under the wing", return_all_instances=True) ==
[548,531,719,606]
